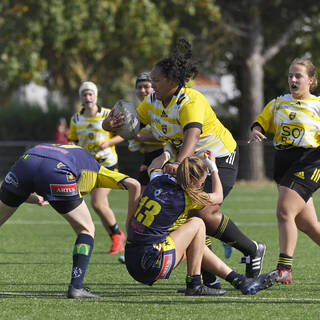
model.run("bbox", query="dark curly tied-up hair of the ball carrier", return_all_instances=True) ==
[155,38,198,87]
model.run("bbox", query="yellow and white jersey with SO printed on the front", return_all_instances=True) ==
[255,94,320,150]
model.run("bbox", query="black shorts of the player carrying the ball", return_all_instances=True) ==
[204,146,239,199]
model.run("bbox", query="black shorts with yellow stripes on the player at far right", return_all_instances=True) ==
[273,148,320,202]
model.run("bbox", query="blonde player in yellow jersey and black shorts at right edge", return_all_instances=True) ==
[248,58,320,284]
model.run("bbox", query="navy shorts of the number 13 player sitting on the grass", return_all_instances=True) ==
[125,236,176,286]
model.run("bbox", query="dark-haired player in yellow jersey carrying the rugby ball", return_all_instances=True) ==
[102,39,266,286]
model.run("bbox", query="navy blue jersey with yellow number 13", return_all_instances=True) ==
[128,172,197,244]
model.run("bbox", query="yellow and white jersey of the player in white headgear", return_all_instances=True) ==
[68,107,118,167]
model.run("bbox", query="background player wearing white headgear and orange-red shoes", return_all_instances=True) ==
[68,81,125,254]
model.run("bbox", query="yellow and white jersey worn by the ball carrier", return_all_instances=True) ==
[137,87,236,157]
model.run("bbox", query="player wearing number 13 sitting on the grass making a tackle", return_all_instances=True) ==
[125,150,276,296]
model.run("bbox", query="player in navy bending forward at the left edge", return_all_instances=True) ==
[0,144,141,299]
